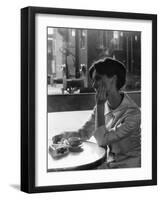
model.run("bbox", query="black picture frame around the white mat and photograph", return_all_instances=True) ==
[21,7,157,193]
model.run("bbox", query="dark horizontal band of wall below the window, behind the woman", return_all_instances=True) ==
[47,91,141,112]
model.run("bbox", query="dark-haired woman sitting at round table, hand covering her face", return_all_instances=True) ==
[53,58,141,168]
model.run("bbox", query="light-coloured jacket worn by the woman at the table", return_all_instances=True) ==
[79,94,141,167]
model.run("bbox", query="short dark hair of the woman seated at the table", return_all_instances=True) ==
[89,58,126,90]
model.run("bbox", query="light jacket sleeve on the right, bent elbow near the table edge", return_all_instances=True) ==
[94,110,141,146]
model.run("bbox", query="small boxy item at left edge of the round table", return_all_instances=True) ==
[49,144,69,158]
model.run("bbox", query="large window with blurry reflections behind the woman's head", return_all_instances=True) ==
[47,27,141,95]
